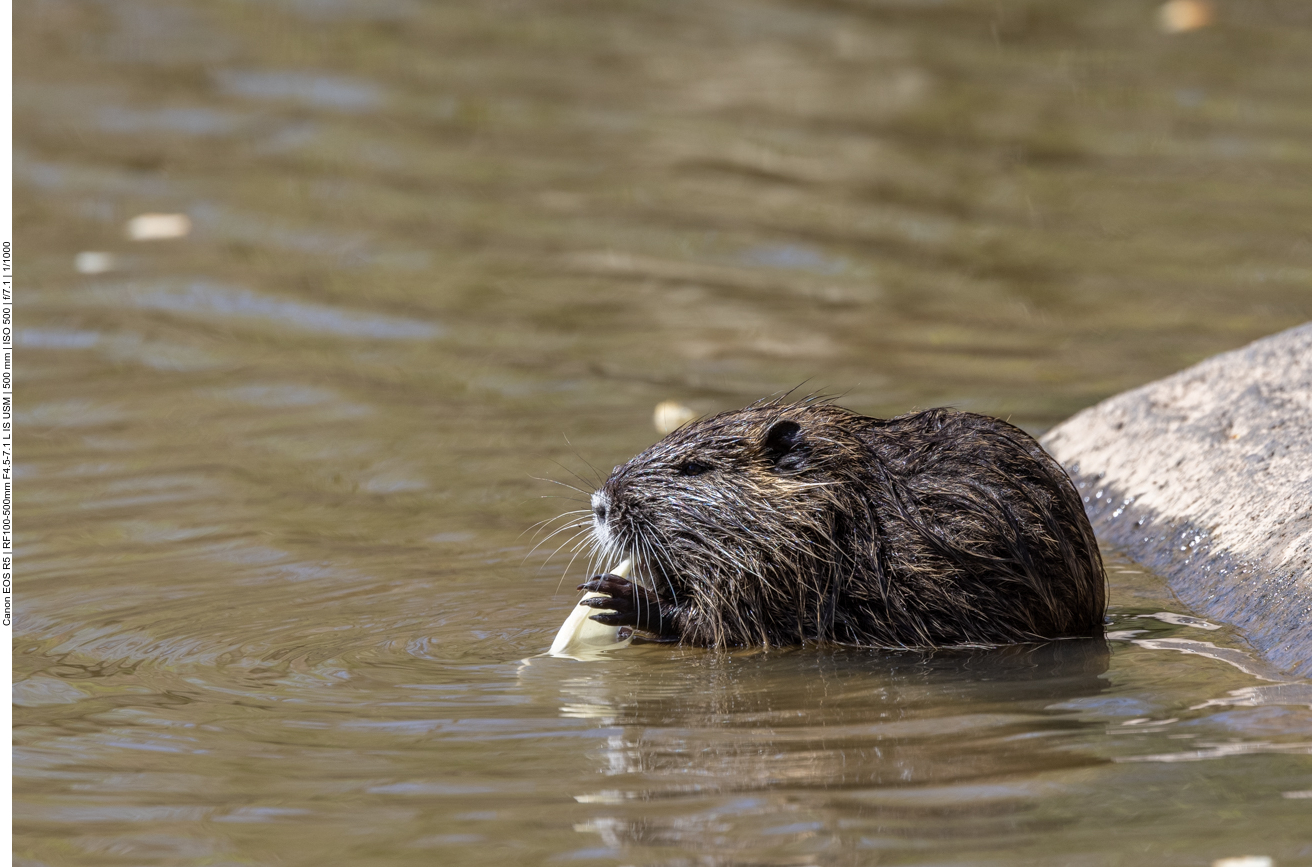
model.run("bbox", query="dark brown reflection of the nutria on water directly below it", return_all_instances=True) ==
[562,641,1110,791]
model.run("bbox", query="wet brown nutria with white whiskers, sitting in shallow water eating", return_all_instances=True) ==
[583,401,1105,647]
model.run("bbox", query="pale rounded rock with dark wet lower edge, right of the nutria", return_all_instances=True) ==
[1042,323,1312,677]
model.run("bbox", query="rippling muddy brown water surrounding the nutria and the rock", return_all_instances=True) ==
[13,0,1312,867]
